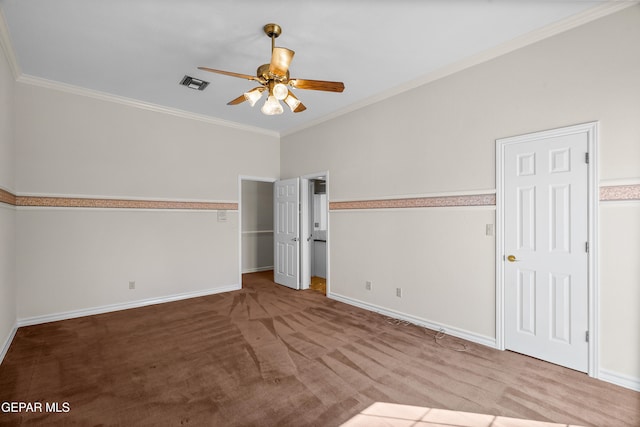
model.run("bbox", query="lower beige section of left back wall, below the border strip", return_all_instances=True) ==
[16,208,239,323]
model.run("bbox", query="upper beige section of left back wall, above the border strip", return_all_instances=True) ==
[16,84,279,202]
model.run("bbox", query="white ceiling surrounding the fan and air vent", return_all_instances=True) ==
[0,0,611,134]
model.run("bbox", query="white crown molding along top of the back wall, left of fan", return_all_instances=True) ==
[16,74,280,137]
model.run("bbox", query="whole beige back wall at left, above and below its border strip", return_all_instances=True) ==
[16,83,279,322]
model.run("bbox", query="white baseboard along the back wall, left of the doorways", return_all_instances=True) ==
[18,285,242,327]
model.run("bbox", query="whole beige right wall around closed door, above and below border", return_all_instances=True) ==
[281,6,640,387]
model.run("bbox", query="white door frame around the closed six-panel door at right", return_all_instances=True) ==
[496,121,600,378]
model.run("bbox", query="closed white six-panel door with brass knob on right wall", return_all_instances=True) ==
[501,132,589,372]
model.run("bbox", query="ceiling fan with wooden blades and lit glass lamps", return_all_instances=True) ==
[198,24,344,115]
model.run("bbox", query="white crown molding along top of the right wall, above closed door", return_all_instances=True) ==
[280,0,640,137]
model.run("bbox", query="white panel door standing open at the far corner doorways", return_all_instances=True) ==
[273,178,300,289]
